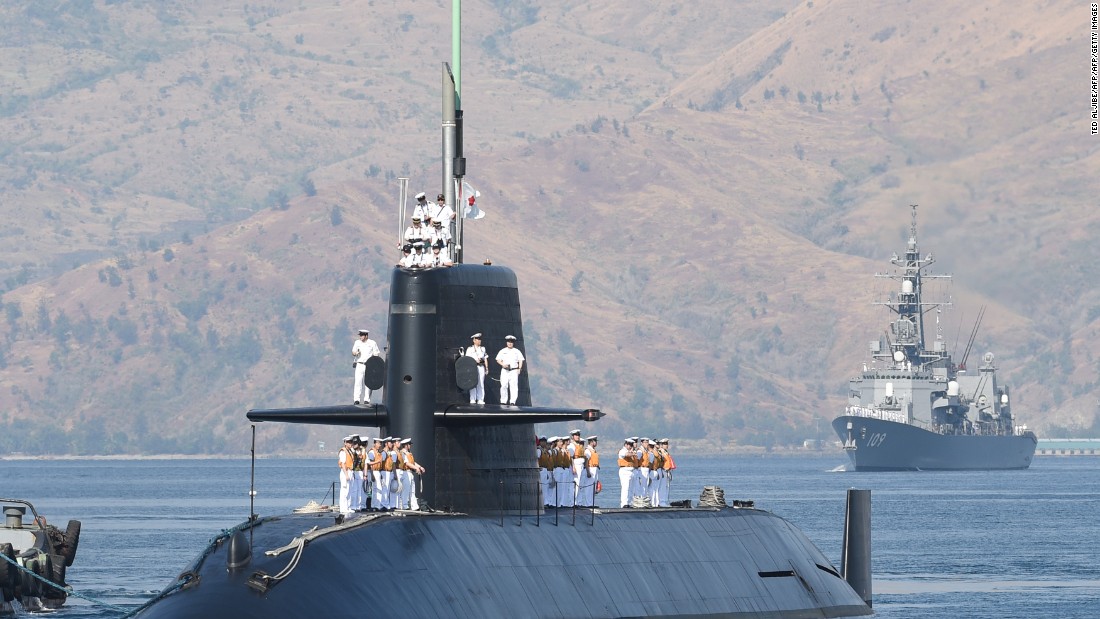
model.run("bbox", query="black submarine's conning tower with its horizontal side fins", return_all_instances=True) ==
[248,264,603,513]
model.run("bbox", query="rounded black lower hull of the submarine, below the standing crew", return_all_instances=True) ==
[130,508,872,619]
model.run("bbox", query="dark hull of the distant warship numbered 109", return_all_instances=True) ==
[833,416,1037,471]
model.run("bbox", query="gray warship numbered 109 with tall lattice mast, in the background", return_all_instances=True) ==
[833,205,1037,471]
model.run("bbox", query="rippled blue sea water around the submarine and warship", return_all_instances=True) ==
[0,454,1100,619]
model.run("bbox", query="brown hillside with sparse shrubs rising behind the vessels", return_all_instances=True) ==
[0,0,1100,453]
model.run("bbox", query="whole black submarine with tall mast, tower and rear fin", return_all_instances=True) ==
[131,21,873,619]
